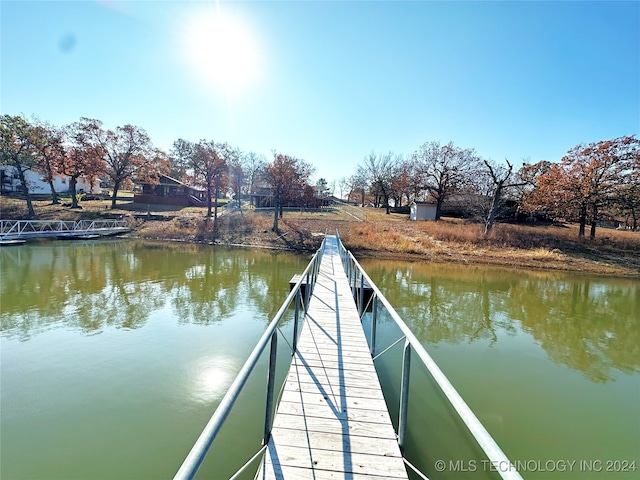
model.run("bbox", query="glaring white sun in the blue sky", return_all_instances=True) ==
[186,13,259,93]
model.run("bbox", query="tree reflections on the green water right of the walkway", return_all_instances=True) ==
[362,260,640,382]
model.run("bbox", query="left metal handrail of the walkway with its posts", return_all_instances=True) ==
[173,240,325,480]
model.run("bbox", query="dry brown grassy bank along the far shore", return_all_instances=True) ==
[5,197,640,278]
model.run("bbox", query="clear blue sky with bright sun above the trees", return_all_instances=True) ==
[0,0,640,185]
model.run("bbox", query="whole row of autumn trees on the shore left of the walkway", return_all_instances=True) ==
[0,115,316,231]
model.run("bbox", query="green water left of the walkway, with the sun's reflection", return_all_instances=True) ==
[0,239,308,480]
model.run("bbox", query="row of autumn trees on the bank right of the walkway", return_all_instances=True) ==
[350,136,640,238]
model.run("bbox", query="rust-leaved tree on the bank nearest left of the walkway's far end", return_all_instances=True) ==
[265,152,311,233]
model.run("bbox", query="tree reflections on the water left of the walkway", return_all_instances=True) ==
[0,240,304,340]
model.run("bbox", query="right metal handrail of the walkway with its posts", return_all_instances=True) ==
[336,232,522,480]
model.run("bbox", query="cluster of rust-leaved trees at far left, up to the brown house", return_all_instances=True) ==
[0,115,168,217]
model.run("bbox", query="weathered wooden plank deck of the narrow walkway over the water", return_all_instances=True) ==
[257,236,407,480]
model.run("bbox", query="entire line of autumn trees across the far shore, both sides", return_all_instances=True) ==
[0,115,640,238]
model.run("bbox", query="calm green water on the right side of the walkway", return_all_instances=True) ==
[361,260,640,479]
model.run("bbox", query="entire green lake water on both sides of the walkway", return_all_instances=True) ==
[0,239,640,479]
